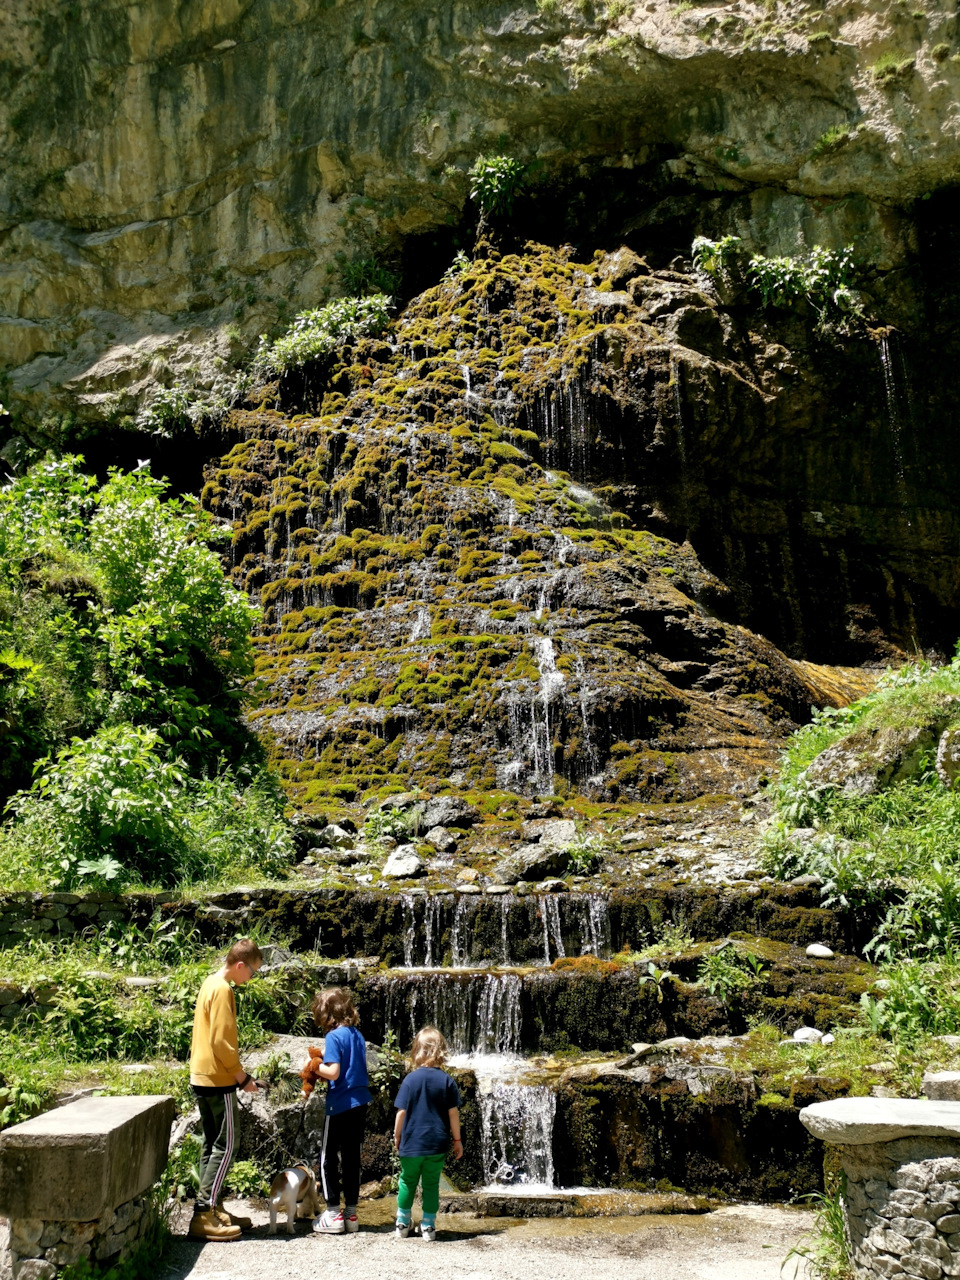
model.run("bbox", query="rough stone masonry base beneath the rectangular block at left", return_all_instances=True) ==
[10,1194,156,1280]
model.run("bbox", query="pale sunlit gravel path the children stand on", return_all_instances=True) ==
[163,1202,813,1280]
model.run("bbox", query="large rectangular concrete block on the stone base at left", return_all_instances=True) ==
[0,1097,175,1222]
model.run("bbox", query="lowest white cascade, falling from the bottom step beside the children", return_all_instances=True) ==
[480,1082,557,1189]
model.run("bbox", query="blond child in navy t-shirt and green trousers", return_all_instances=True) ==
[393,1027,463,1240]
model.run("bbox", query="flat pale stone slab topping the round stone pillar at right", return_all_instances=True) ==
[800,1098,960,1146]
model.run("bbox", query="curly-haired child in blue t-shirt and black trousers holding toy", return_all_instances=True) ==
[311,987,371,1235]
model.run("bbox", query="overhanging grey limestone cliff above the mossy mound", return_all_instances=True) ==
[0,0,960,434]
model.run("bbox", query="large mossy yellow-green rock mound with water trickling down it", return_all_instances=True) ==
[204,244,870,809]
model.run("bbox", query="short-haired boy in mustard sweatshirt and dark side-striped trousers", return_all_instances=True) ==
[189,938,262,1240]
